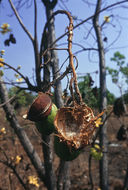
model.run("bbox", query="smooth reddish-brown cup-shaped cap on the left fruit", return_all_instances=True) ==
[27,92,52,122]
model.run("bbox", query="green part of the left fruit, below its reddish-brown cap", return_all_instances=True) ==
[35,104,57,135]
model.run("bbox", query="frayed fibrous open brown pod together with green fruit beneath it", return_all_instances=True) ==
[54,104,103,161]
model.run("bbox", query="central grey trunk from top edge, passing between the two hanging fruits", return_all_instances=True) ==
[42,0,70,190]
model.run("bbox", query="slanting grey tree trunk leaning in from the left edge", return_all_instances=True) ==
[0,77,46,184]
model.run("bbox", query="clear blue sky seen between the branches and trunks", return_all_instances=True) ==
[0,0,128,96]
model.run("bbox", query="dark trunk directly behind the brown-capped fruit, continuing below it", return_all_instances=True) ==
[42,32,57,190]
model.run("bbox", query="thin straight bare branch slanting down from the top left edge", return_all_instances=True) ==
[8,0,34,43]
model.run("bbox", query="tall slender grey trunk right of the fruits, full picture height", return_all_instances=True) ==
[93,0,108,190]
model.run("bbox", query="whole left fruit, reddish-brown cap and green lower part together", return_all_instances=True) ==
[27,93,57,135]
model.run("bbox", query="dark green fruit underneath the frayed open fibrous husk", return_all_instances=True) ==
[54,136,81,161]
